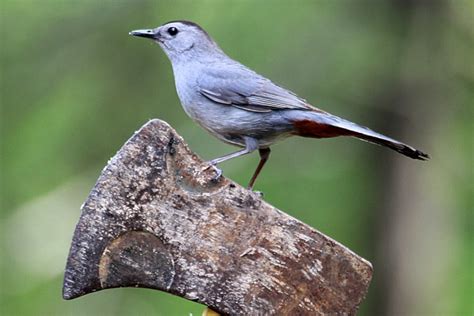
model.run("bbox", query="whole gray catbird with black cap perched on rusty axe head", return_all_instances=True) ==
[130,21,429,189]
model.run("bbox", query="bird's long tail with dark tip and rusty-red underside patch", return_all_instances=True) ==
[290,111,430,160]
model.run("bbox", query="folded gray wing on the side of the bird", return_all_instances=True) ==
[197,64,315,112]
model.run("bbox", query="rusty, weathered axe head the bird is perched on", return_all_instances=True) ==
[63,120,372,315]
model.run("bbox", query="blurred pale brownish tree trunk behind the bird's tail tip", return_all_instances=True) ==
[374,0,452,315]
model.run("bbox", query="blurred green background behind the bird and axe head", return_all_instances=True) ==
[0,0,474,315]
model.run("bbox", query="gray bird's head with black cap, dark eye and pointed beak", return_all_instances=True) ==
[129,21,221,62]
